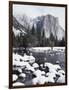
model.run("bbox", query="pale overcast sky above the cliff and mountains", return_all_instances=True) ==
[13,4,65,29]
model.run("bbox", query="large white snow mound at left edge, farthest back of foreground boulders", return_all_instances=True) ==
[13,53,35,66]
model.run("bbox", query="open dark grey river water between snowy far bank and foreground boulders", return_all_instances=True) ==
[32,52,65,70]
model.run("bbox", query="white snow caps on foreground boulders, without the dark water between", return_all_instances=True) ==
[13,49,65,86]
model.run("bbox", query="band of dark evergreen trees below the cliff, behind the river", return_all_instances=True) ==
[13,25,65,48]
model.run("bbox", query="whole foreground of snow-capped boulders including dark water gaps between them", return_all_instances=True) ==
[13,53,65,86]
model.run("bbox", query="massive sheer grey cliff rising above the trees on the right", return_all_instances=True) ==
[33,14,65,40]
